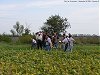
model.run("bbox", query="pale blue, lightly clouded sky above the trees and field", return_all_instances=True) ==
[0,0,100,35]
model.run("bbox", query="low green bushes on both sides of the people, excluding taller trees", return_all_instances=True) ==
[0,34,100,44]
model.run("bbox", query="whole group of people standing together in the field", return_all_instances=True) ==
[32,32,75,52]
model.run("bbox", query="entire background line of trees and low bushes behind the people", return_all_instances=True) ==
[0,15,100,44]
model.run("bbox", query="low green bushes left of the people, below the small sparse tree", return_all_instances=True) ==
[0,34,35,44]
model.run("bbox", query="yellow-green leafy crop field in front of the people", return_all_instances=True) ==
[0,44,100,75]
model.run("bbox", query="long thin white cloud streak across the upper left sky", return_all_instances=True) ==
[0,0,64,10]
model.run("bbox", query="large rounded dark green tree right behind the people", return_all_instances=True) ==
[41,15,70,34]
